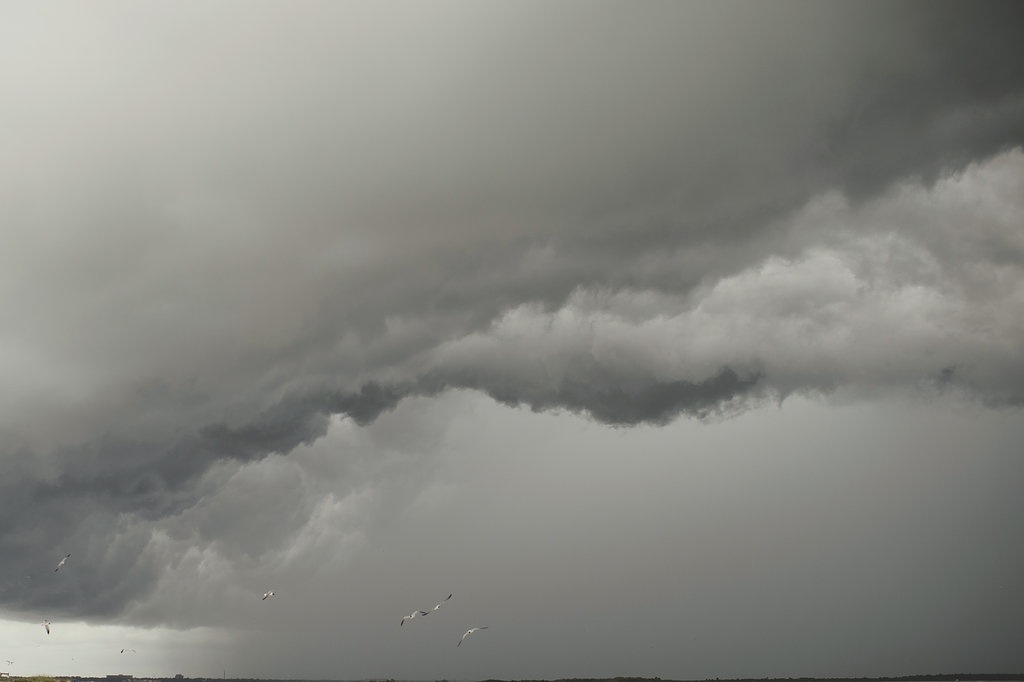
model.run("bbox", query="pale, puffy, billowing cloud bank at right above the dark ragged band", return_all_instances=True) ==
[424,150,1024,401]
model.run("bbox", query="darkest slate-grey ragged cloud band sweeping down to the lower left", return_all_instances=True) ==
[0,360,760,616]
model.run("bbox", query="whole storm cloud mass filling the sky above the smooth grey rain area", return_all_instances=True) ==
[0,2,1024,672]
